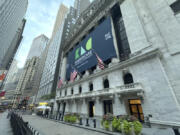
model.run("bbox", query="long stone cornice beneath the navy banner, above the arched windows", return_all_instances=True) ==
[57,48,161,90]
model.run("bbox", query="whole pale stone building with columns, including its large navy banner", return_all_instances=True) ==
[54,0,180,124]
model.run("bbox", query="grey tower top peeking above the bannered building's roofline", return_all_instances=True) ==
[74,0,91,17]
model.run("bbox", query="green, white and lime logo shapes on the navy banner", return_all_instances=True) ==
[75,38,92,60]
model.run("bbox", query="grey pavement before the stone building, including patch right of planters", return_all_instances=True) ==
[22,115,175,135]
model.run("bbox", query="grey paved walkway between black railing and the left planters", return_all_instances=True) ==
[22,115,107,135]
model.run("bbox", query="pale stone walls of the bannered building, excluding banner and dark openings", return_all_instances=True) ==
[55,0,180,124]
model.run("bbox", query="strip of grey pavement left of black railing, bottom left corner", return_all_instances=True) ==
[0,112,13,135]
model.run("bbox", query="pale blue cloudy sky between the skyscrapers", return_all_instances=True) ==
[15,0,74,68]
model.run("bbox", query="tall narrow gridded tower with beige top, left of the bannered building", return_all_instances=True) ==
[37,4,68,101]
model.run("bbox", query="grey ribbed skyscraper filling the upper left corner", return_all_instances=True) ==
[0,0,28,69]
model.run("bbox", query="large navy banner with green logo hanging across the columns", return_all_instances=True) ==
[66,17,117,80]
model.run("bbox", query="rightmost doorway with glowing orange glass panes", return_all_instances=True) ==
[129,99,144,122]
